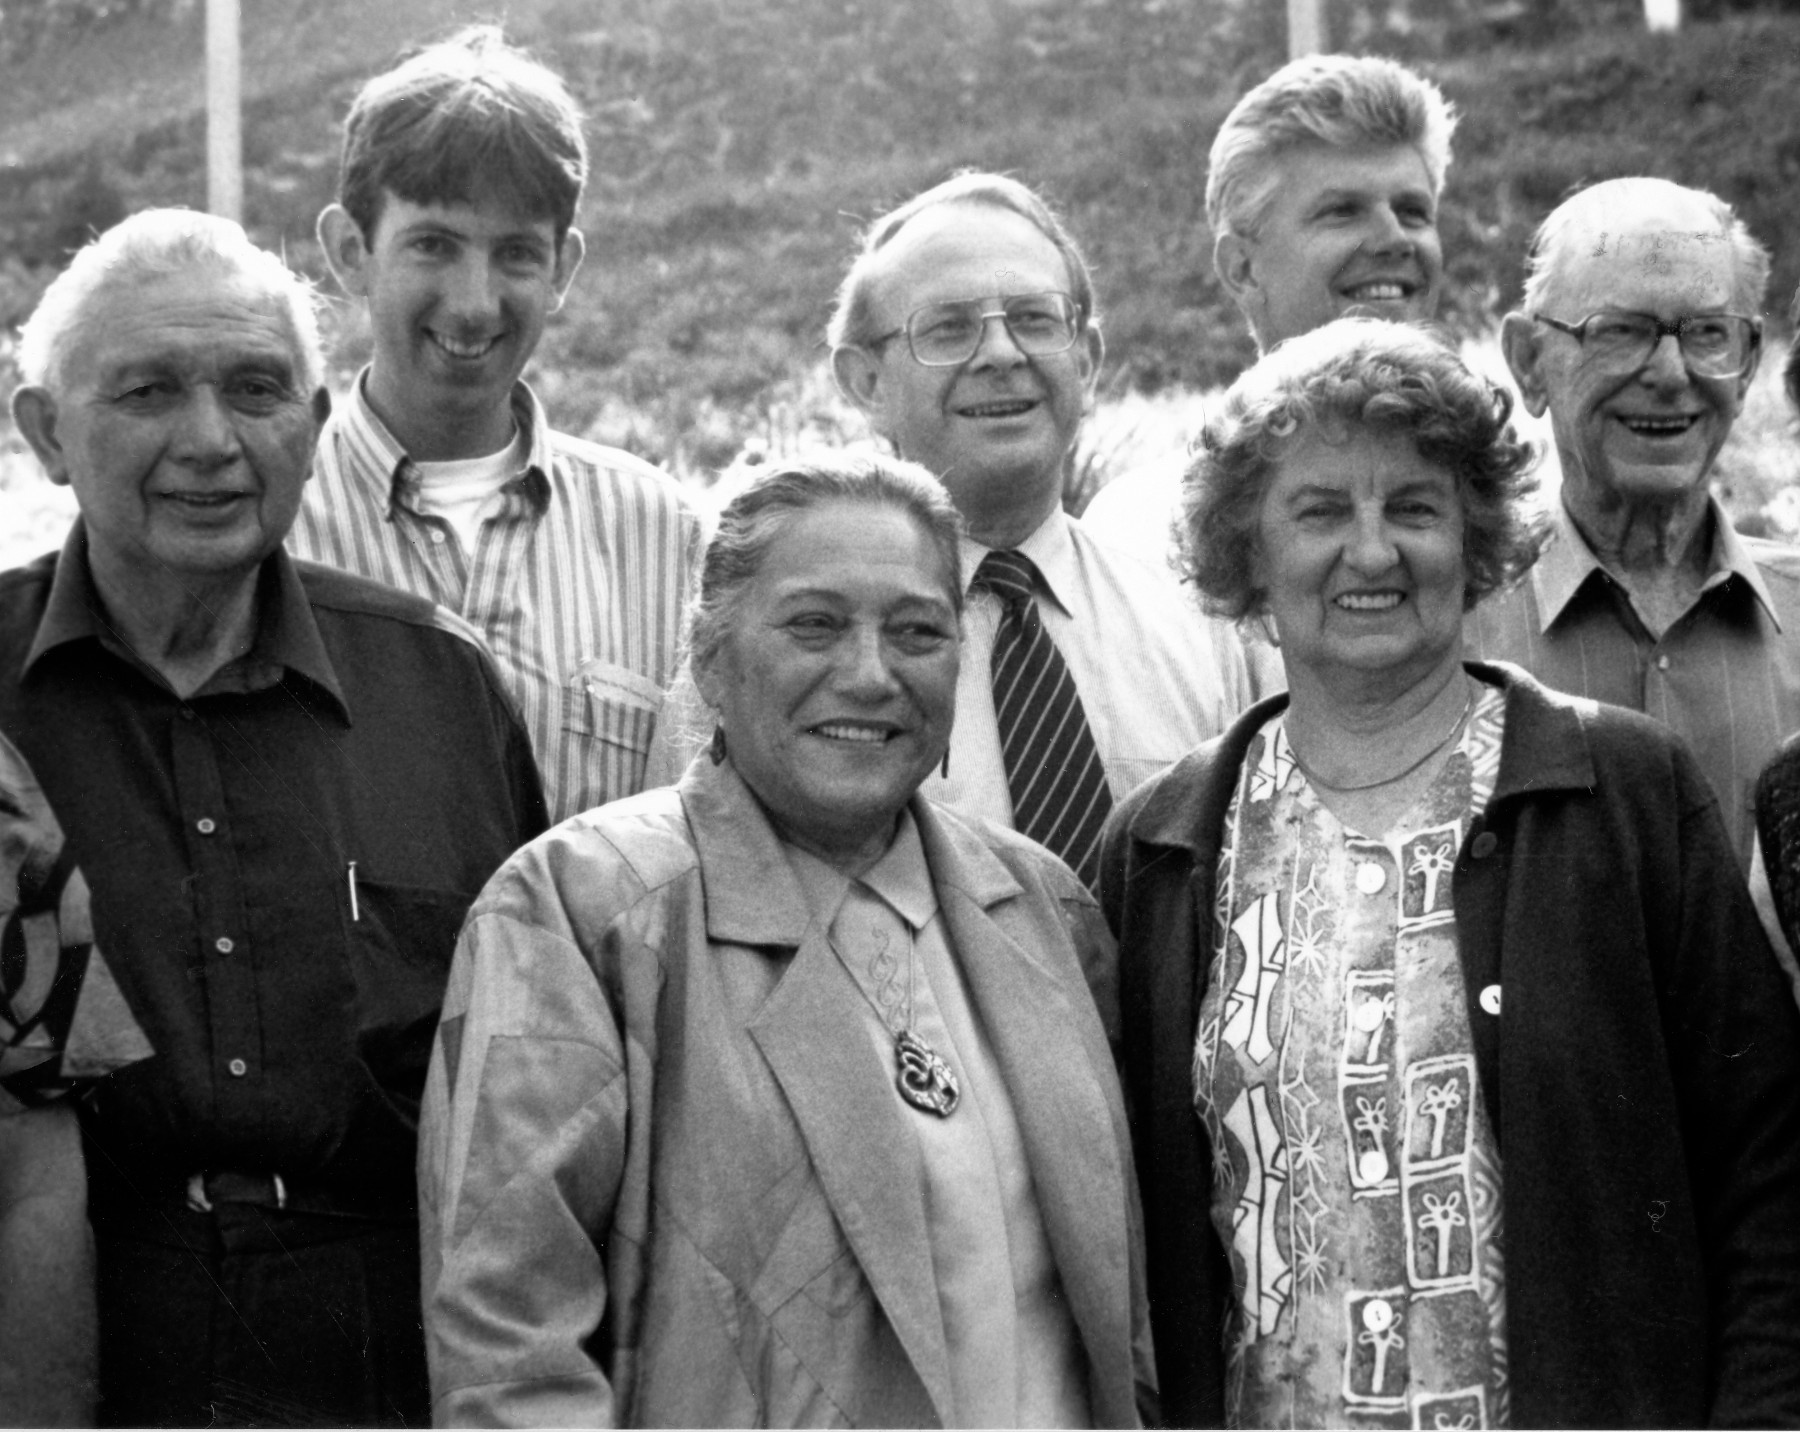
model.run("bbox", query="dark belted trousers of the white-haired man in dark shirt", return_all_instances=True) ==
[94,1202,430,1427]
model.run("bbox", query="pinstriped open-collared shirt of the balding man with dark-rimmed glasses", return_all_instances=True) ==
[1465,498,1800,865]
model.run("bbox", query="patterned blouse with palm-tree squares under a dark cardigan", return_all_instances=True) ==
[1193,687,1507,1428]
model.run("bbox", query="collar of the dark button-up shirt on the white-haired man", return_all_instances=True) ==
[22,516,349,721]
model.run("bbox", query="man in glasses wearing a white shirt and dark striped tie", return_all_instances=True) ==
[828,173,1251,883]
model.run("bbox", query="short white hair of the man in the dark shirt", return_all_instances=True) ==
[18,209,326,390]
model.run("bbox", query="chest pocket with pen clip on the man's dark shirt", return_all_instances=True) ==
[342,880,475,1126]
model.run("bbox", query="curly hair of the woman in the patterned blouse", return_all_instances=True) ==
[1177,318,1548,621]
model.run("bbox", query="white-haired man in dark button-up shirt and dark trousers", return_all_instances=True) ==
[0,210,545,1425]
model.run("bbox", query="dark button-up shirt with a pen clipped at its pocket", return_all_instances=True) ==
[0,524,545,1200]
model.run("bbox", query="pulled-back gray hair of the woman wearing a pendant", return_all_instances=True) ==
[688,452,963,669]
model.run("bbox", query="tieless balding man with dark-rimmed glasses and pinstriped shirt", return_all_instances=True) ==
[1469,178,1800,864]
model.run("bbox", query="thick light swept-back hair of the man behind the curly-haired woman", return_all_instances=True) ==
[1206,54,1456,237]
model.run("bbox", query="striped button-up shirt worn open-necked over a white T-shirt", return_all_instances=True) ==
[288,372,700,820]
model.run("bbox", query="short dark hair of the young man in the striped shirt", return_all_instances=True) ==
[338,25,587,243]
